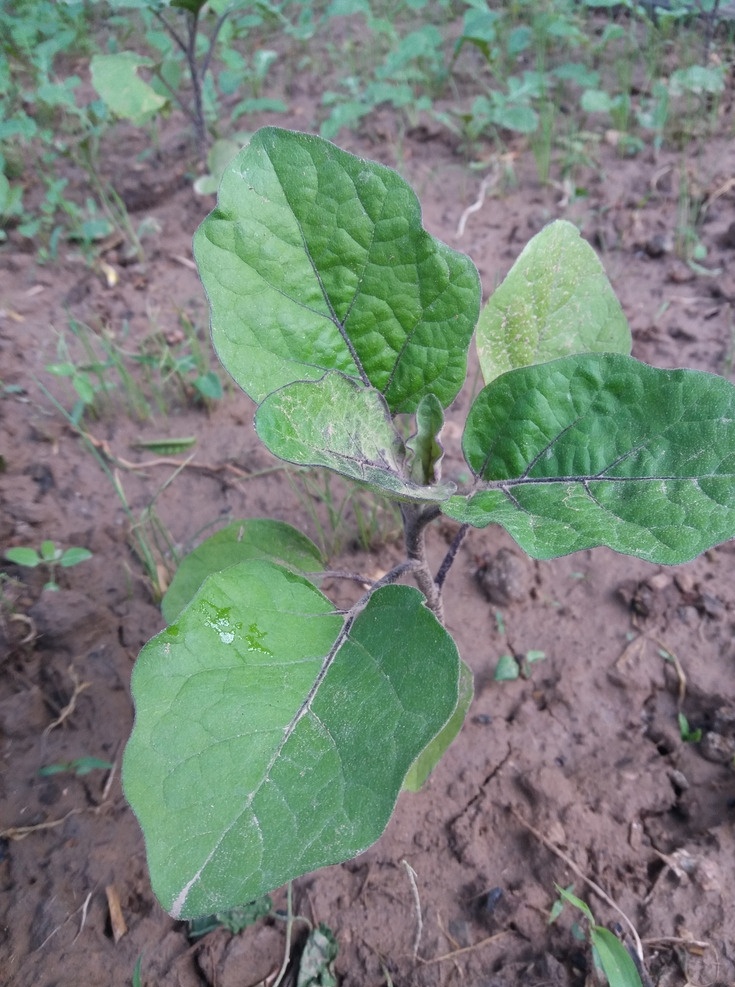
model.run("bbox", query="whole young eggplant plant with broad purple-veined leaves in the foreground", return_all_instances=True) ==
[124,128,735,918]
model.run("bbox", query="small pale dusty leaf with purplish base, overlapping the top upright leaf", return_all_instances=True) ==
[255,373,454,501]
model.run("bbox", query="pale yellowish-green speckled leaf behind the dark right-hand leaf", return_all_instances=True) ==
[477,219,631,383]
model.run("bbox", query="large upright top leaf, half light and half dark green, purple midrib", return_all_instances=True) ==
[194,127,480,414]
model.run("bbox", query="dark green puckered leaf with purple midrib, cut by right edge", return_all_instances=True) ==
[442,354,735,564]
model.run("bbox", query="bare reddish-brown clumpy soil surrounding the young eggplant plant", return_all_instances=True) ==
[0,96,735,987]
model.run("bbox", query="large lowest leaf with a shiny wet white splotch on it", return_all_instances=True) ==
[123,561,459,918]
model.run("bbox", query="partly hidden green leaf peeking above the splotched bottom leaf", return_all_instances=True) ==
[161,518,324,624]
